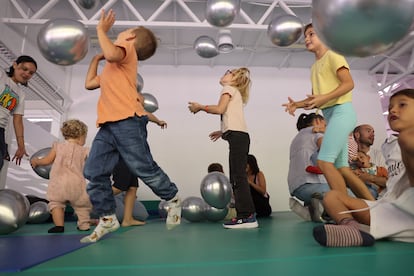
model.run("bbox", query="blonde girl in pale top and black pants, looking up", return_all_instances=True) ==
[188,67,258,228]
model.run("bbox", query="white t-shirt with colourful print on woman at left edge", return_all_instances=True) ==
[0,70,25,128]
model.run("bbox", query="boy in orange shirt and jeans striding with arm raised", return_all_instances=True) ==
[81,10,181,242]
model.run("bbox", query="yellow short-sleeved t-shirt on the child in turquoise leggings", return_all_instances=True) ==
[311,50,352,109]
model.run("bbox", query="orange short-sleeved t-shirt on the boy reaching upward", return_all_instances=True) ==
[96,40,146,127]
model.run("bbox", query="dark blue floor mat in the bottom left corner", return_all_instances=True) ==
[0,234,90,272]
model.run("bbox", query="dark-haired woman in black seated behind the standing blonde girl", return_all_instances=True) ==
[246,154,272,218]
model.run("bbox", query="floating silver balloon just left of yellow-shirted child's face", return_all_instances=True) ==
[267,14,303,47]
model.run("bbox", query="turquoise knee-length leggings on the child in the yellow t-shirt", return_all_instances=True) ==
[318,102,356,168]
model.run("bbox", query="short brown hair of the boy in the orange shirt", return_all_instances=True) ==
[132,27,158,60]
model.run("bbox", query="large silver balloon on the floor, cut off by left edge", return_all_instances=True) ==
[0,189,30,235]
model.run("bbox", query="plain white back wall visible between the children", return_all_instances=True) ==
[67,65,386,211]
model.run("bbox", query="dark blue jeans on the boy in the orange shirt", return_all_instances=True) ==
[84,116,178,216]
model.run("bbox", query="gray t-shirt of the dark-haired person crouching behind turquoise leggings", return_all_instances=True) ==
[288,126,328,194]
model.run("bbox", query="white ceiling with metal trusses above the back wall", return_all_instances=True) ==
[1,0,414,109]
